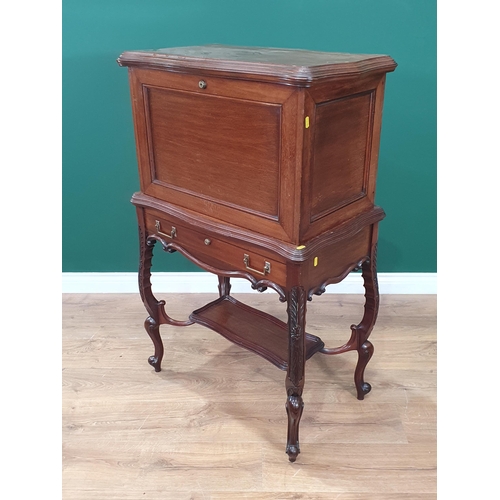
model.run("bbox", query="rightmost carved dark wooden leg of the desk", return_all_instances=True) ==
[351,245,379,399]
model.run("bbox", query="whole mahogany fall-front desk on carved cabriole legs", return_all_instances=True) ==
[118,45,396,462]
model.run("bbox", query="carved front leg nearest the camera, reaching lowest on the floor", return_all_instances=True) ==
[285,287,307,462]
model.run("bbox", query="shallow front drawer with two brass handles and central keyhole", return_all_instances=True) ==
[146,212,286,286]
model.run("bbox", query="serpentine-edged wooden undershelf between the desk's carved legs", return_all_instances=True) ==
[190,296,324,370]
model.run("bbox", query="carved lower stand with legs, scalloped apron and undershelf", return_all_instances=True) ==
[139,212,379,462]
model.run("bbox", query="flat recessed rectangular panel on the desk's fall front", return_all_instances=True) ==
[144,86,282,221]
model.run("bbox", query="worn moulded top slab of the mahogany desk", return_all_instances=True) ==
[118,45,397,83]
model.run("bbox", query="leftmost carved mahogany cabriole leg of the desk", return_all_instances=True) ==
[139,226,165,372]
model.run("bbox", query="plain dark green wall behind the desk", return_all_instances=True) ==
[62,0,436,272]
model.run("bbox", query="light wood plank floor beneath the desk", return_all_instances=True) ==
[62,293,436,500]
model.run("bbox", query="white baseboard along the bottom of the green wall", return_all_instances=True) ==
[62,272,437,295]
